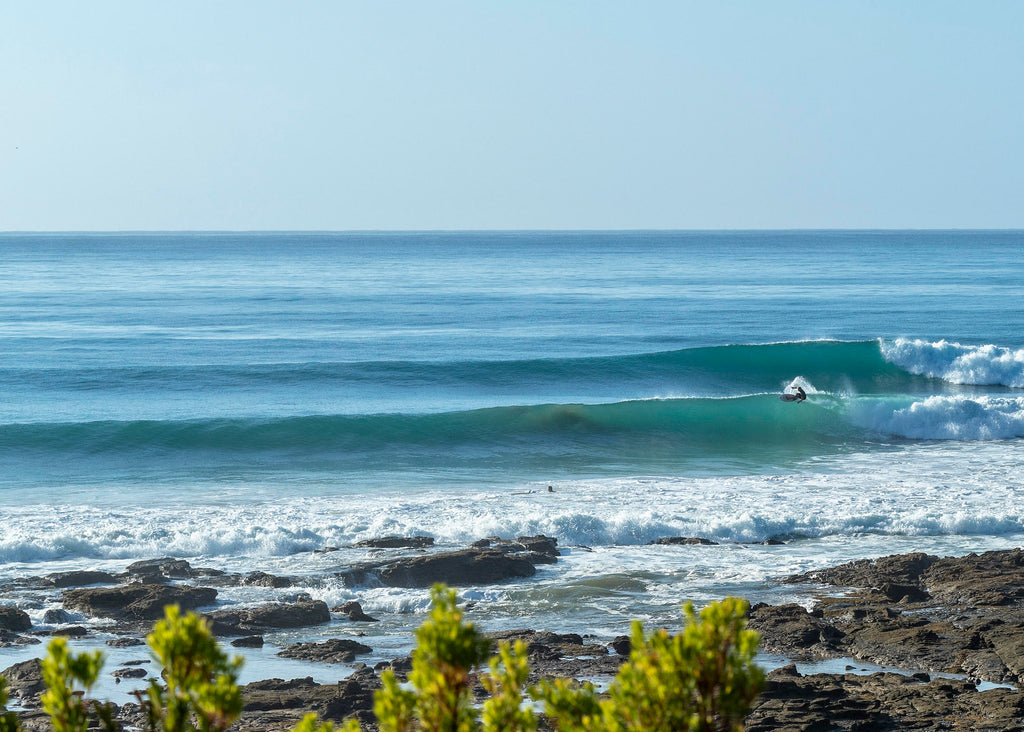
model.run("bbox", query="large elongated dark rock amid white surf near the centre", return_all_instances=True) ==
[377,549,537,588]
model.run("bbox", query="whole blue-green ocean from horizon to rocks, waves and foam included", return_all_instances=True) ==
[0,231,1024,696]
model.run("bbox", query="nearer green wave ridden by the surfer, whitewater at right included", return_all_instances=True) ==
[0,394,1024,454]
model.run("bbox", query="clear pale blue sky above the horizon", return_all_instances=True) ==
[0,0,1024,231]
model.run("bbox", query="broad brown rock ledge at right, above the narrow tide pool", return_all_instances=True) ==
[750,549,1024,686]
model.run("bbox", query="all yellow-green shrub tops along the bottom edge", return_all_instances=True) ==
[8,585,764,732]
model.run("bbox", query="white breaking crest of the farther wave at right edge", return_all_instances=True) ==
[882,338,1024,388]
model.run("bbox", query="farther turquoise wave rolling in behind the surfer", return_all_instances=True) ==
[0,341,1003,423]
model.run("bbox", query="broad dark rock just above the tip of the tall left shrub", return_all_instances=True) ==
[63,585,217,620]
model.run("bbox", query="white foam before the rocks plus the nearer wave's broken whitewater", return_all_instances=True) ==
[6,440,1024,577]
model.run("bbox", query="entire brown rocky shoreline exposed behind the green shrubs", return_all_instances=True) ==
[0,536,1024,732]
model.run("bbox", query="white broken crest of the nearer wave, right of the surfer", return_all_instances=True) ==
[854,396,1024,440]
